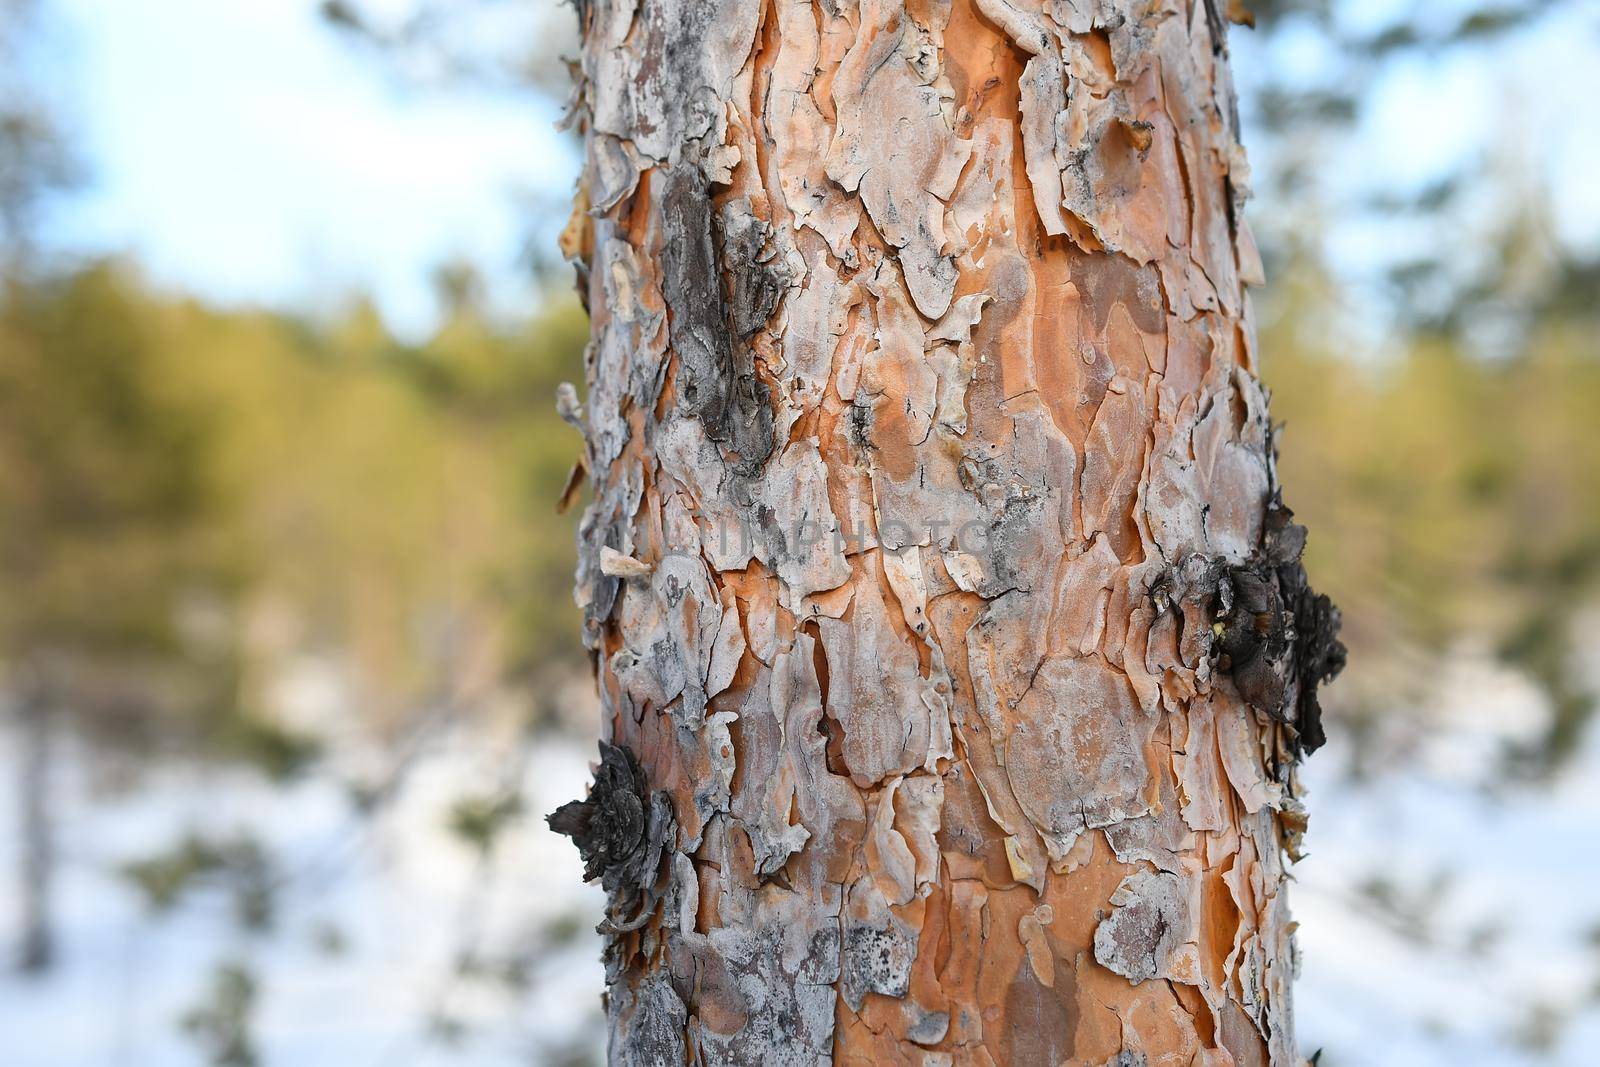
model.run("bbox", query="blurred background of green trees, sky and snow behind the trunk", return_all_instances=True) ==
[0,0,1600,1067]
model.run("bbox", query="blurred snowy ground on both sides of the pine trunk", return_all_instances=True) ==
[0,661,1600,1067]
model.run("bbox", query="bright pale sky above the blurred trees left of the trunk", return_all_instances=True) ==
[46,0,576,333]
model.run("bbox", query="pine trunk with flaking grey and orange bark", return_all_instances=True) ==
[550,0,1342,1064]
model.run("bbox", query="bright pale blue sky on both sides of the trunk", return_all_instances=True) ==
[25,0,1600,336]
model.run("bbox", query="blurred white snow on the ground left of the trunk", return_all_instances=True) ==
[0,733,602,1067]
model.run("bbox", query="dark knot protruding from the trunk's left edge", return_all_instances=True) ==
[546,741,674,933]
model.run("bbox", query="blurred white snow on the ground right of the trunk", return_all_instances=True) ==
[1291,657,1600,1067]
